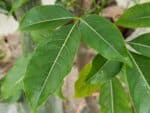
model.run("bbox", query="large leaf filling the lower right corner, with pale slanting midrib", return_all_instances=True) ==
[126,54,150,113]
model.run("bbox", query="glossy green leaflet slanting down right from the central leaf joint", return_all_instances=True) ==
[80,15,130,64]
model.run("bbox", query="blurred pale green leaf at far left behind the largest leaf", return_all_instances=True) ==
[1,57,29,101]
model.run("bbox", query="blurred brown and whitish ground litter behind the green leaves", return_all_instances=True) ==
[0,0,150,113]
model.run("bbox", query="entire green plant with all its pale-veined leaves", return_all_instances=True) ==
[2,3,150,113]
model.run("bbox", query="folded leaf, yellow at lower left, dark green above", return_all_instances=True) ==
[75,54,122,97]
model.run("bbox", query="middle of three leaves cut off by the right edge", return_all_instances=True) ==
[128,33,150,57]
